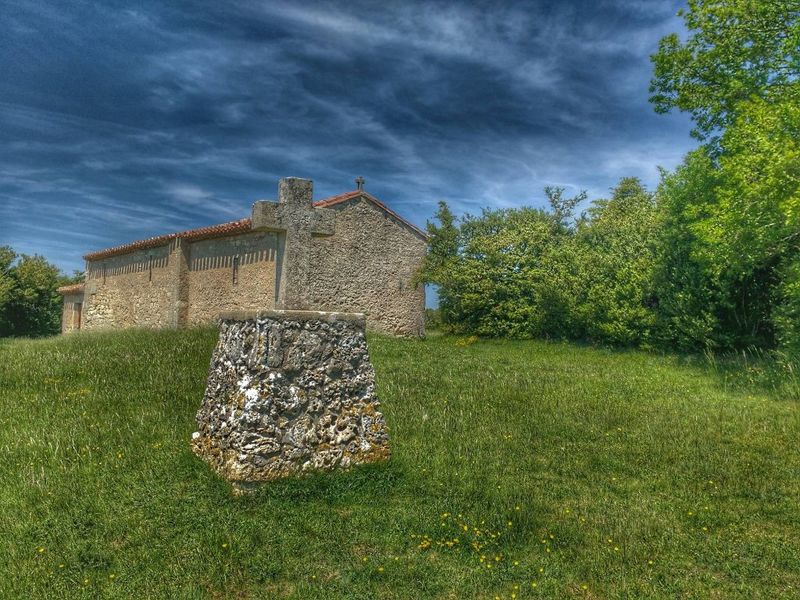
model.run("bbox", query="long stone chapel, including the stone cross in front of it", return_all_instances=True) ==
[58,177,427,336]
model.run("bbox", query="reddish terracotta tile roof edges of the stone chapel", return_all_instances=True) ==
[84,190,428,260]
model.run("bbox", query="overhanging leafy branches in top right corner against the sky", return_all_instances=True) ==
[650,0,800,139]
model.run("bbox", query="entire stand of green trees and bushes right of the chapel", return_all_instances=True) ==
[422,0,800,352]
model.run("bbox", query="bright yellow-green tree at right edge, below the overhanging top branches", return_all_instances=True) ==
[700,99,800,347]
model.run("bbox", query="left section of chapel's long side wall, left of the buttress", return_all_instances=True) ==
[83,244,177,329]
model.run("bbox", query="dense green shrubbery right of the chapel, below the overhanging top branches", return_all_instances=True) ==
[422,145,800,355]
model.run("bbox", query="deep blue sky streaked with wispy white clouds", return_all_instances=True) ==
[0,0,694,271]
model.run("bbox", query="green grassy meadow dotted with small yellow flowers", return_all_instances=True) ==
[0,330,800,599]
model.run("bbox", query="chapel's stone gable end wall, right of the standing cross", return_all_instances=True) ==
[309,198,427,336]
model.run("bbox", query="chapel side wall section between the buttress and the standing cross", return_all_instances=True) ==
[186,232,278,325]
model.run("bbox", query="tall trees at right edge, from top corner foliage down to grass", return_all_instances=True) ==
[650,0,800,348]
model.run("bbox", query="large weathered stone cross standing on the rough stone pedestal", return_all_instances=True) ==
[252,177,335,310]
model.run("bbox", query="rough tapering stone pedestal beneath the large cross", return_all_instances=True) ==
[192,311,389,490]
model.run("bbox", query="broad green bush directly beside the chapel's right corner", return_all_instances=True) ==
[422,188,586,337]
